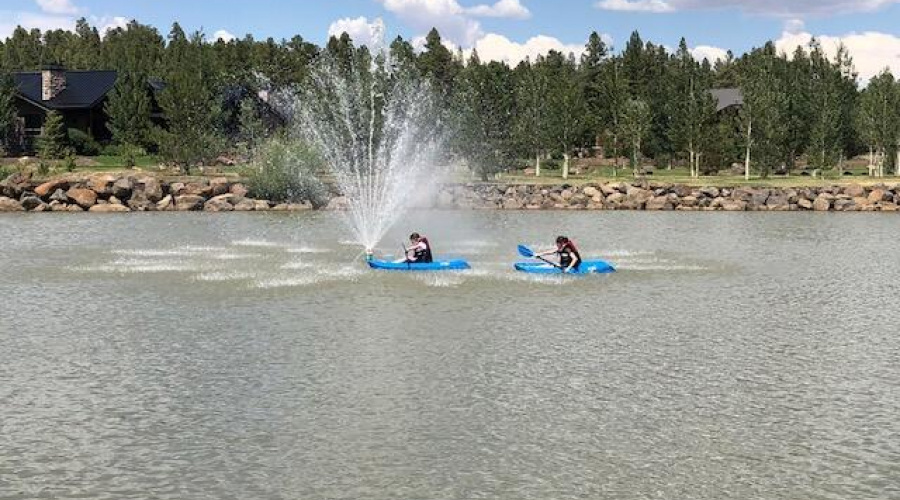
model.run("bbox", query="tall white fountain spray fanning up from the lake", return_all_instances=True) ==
[272,21,442,250]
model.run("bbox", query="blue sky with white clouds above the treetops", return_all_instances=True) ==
[0,0,900,81]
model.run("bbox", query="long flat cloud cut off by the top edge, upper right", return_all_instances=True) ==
[595,0,900,17]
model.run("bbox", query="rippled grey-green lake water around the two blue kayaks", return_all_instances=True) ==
[0,211,900,500]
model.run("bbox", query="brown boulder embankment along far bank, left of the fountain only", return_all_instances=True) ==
[0,174,313,213]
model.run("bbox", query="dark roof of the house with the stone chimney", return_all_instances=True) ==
[14,71,116,109]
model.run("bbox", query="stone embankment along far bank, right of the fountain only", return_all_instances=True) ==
[437,182,900,212]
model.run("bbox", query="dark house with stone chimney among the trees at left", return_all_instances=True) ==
[13,66,116,151]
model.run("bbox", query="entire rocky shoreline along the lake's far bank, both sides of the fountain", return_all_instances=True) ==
[0,174,900,213]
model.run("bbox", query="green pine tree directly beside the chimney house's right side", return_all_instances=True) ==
[105,71,153,149]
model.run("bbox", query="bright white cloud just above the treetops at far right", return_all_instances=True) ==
[775,31,900,83]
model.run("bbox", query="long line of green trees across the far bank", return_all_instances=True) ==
[0,19,900,178]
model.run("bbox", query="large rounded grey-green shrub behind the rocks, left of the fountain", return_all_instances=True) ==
[247,138,326,206]
